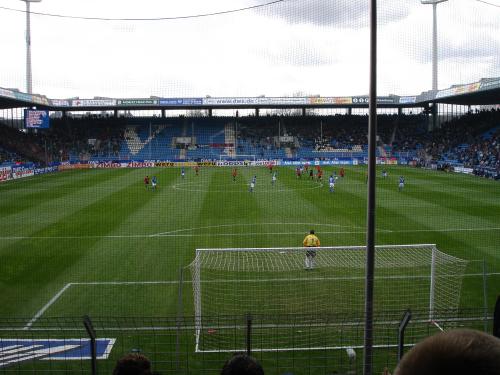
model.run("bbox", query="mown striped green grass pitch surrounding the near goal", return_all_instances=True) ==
[0,167,500,373]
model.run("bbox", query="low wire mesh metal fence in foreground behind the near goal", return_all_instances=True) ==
[0,309,492,375]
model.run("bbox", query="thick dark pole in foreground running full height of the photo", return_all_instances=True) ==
[363,0,377,375]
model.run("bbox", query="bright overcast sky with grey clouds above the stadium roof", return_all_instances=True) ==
[0,0,500,98]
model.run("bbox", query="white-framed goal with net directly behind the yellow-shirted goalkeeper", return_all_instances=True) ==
[189,245,467,351]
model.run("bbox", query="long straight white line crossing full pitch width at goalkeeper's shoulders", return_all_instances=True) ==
[0,227,500,241]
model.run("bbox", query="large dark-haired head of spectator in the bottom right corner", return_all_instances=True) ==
[394,329,500,375]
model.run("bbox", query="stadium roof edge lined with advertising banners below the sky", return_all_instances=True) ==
[0,77,500,111]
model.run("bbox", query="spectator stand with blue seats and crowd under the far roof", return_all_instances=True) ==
[0,110,500,177]
